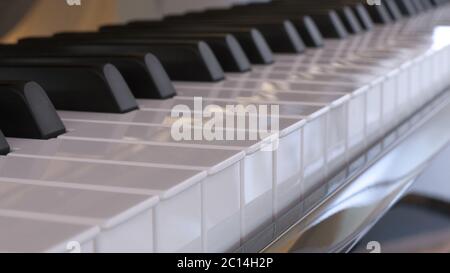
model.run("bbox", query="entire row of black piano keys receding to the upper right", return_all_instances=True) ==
[0,0,448,154]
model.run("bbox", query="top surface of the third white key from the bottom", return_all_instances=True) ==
[0,154,207,194]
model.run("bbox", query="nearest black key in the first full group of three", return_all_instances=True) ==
[14,38,225,82]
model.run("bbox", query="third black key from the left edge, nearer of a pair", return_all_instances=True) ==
[0,58,138,113]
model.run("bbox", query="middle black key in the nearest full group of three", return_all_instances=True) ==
[54,31,251,72]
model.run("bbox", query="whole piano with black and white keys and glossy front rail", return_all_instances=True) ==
[0,0,450,253]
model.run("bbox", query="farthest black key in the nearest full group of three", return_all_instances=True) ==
[100,23,274,64]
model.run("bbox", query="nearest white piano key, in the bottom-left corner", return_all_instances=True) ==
[0,212,100,253]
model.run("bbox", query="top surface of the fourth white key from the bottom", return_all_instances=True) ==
[7,138,243,171]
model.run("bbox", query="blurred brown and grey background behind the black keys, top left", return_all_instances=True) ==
[0,0,270,42]
